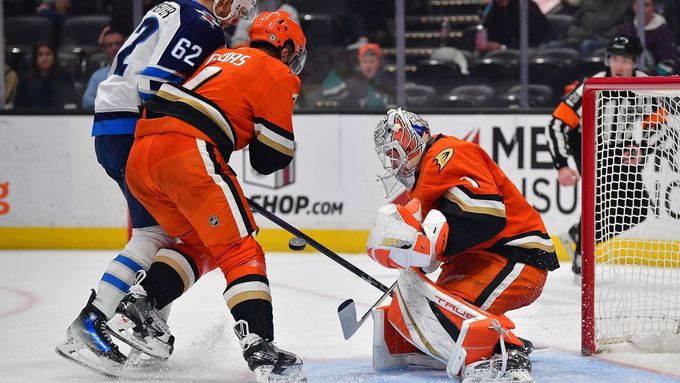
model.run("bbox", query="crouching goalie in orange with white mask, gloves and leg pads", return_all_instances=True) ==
[366,109,559,382]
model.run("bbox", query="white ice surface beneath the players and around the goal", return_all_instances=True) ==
[0,251,680,383]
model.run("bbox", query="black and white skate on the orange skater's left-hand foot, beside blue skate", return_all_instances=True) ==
[108,273,175,359]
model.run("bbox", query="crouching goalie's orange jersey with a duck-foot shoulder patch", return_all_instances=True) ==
[409,135,559,270]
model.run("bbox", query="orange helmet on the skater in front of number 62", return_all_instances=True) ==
[248,10,307,75]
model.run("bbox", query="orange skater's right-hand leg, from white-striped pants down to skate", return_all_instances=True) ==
[128,134,302,381]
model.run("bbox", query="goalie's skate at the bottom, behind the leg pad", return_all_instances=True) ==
[461,350,535,383]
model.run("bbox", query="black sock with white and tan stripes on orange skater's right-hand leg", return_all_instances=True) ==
[223,274,274,340]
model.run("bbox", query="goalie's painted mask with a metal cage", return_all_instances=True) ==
[373,108,430,197]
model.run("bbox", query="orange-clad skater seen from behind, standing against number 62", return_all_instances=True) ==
[114,11,306,382]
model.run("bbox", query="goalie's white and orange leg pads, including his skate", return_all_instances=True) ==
[374,269,531,382]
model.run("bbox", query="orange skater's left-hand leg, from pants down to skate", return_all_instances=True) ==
[109,137,214,358]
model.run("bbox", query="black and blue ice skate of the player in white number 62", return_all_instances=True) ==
[55,290,127,378]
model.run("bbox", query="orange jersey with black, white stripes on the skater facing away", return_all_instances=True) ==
[135,48,300,174]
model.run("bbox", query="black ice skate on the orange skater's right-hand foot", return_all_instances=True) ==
[234,320,307,383]
